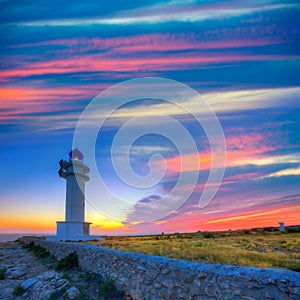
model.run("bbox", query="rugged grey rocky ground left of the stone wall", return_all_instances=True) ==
[0,242,125,300]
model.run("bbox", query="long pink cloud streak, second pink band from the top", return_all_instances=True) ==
[0,54,300,82]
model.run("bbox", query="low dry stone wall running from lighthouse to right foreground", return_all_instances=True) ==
[34,239,300,300]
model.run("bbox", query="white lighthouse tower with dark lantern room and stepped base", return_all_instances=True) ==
[47,148,99,241]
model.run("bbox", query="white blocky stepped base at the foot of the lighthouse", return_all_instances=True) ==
[46,221,103,242]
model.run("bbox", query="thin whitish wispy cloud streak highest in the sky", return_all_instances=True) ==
[11,3,298,27]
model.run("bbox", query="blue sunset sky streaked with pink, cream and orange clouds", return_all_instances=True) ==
[0,0,300,234]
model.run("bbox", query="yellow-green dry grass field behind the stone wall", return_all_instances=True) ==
[89,229,300,272]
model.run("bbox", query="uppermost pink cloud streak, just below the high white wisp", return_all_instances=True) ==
[12,30,285,54]
